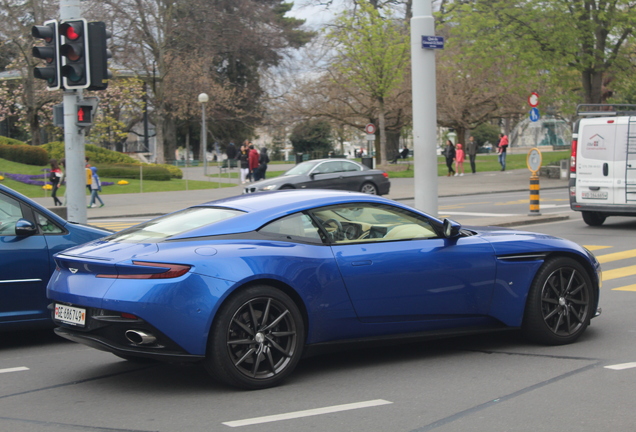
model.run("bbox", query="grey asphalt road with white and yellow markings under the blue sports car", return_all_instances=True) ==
[0,195,636,432]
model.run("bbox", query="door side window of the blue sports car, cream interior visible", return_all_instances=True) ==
[313,203,438,244]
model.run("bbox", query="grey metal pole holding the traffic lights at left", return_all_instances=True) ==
[60,0,87,223]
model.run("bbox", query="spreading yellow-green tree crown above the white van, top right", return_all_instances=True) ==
[444,0,636,103]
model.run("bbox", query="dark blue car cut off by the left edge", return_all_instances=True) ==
[0,185,111,331]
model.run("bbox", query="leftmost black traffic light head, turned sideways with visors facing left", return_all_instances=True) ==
[31,20,61,90]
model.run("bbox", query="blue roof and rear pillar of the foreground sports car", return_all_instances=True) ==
[172,189,413,239]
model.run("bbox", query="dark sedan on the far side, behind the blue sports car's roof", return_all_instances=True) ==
[243,159,391,195]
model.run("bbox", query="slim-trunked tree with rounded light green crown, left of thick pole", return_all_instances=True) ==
[328,0,409,163]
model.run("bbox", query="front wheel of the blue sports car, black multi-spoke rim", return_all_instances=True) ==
[521,257,596,345]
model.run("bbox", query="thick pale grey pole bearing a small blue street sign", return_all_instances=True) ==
[411,0,438,216]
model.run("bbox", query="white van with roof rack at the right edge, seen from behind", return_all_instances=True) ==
[569,104,636,226]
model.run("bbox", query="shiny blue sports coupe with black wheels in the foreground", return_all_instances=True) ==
[48,190,601,389]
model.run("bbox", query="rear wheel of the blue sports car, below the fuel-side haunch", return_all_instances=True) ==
[204,285,305,390]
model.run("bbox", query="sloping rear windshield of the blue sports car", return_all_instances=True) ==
[105,207,243,243]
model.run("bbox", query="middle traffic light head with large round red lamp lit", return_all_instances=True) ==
[59,18,91,90]
